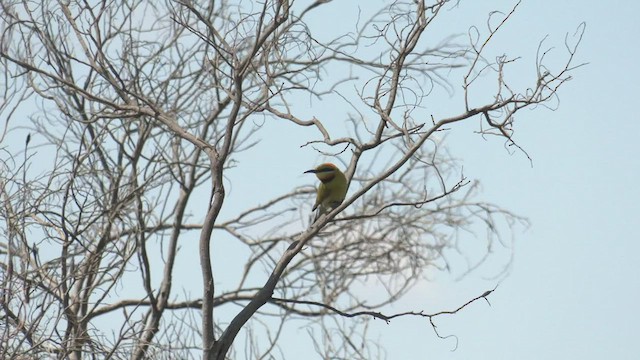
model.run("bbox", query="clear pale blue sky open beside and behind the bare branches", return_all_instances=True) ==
[2,0,640,360]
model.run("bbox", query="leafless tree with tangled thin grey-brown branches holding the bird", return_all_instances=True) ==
[0,0,584,359]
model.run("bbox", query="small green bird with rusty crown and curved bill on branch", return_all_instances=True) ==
[305,163,349,222]
